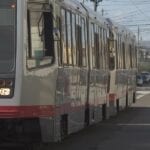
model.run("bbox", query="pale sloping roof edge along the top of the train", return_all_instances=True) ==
[31,0,134,36]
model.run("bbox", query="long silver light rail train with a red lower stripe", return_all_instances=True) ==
[0,0,137,142]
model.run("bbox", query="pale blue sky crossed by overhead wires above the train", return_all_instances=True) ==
[78,0,150,41]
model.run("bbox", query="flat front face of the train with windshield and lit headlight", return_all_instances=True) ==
[0,0,23,118]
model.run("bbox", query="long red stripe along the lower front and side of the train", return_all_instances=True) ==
[0,95,109,118]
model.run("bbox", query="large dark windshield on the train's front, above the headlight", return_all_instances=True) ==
[0,0,17,73]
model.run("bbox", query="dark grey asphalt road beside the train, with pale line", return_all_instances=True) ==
[42,94,150,150]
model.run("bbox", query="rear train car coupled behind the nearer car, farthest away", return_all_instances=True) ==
[107,19,137,115]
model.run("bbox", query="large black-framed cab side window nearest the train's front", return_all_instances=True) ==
[27,2,55,69]
